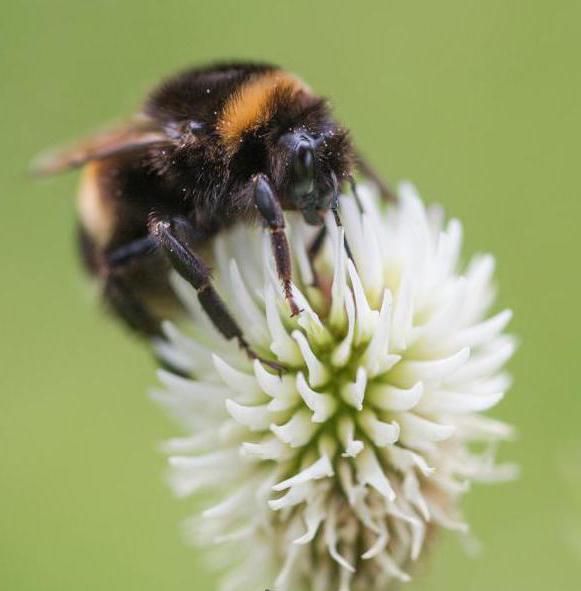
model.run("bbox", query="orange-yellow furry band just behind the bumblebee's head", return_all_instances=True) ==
[216,70,309,151]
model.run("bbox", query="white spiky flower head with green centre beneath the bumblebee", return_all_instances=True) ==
[154,185,515,591]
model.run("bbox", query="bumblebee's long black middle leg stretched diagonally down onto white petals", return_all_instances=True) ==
[149,217,282,371]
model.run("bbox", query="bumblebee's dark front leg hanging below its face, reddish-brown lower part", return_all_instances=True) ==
[253,174,301,316]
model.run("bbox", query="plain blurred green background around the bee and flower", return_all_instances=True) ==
[0,0,581,591]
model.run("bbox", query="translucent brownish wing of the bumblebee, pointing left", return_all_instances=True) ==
[32,118,169,175]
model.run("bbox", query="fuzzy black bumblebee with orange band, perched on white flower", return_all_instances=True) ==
[37,63,390,358]
